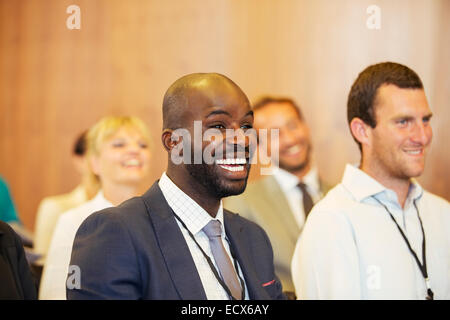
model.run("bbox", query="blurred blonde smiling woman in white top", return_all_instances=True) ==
[39,116,151,299]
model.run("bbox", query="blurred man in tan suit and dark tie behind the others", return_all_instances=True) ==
[224,97,329,299]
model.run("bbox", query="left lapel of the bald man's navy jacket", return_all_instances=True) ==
[143,182,206,300]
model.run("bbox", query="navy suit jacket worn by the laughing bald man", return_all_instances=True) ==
[67,182,284,300]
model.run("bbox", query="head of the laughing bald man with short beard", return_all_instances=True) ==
[161,73,253,205]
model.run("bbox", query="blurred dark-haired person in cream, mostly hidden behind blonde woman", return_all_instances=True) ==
[34,131,99,258]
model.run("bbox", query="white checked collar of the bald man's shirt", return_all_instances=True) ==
[158,172,225,236]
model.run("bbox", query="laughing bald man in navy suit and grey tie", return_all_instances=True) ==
[67,73,284,300]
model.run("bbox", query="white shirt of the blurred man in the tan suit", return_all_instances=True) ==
[273,167,322,229]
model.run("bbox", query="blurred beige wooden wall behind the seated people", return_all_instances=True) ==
[0,0,450,229]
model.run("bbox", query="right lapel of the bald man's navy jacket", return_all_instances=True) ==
[224,210,270,300]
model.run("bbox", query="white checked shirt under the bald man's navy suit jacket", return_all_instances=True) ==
[158,172,248,300]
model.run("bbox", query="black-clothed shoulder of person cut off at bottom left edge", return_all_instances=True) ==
[0,221,37,300]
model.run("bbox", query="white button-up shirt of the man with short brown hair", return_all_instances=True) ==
[292,165,450,299]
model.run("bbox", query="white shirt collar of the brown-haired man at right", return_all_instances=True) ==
[342,164,423,202]
